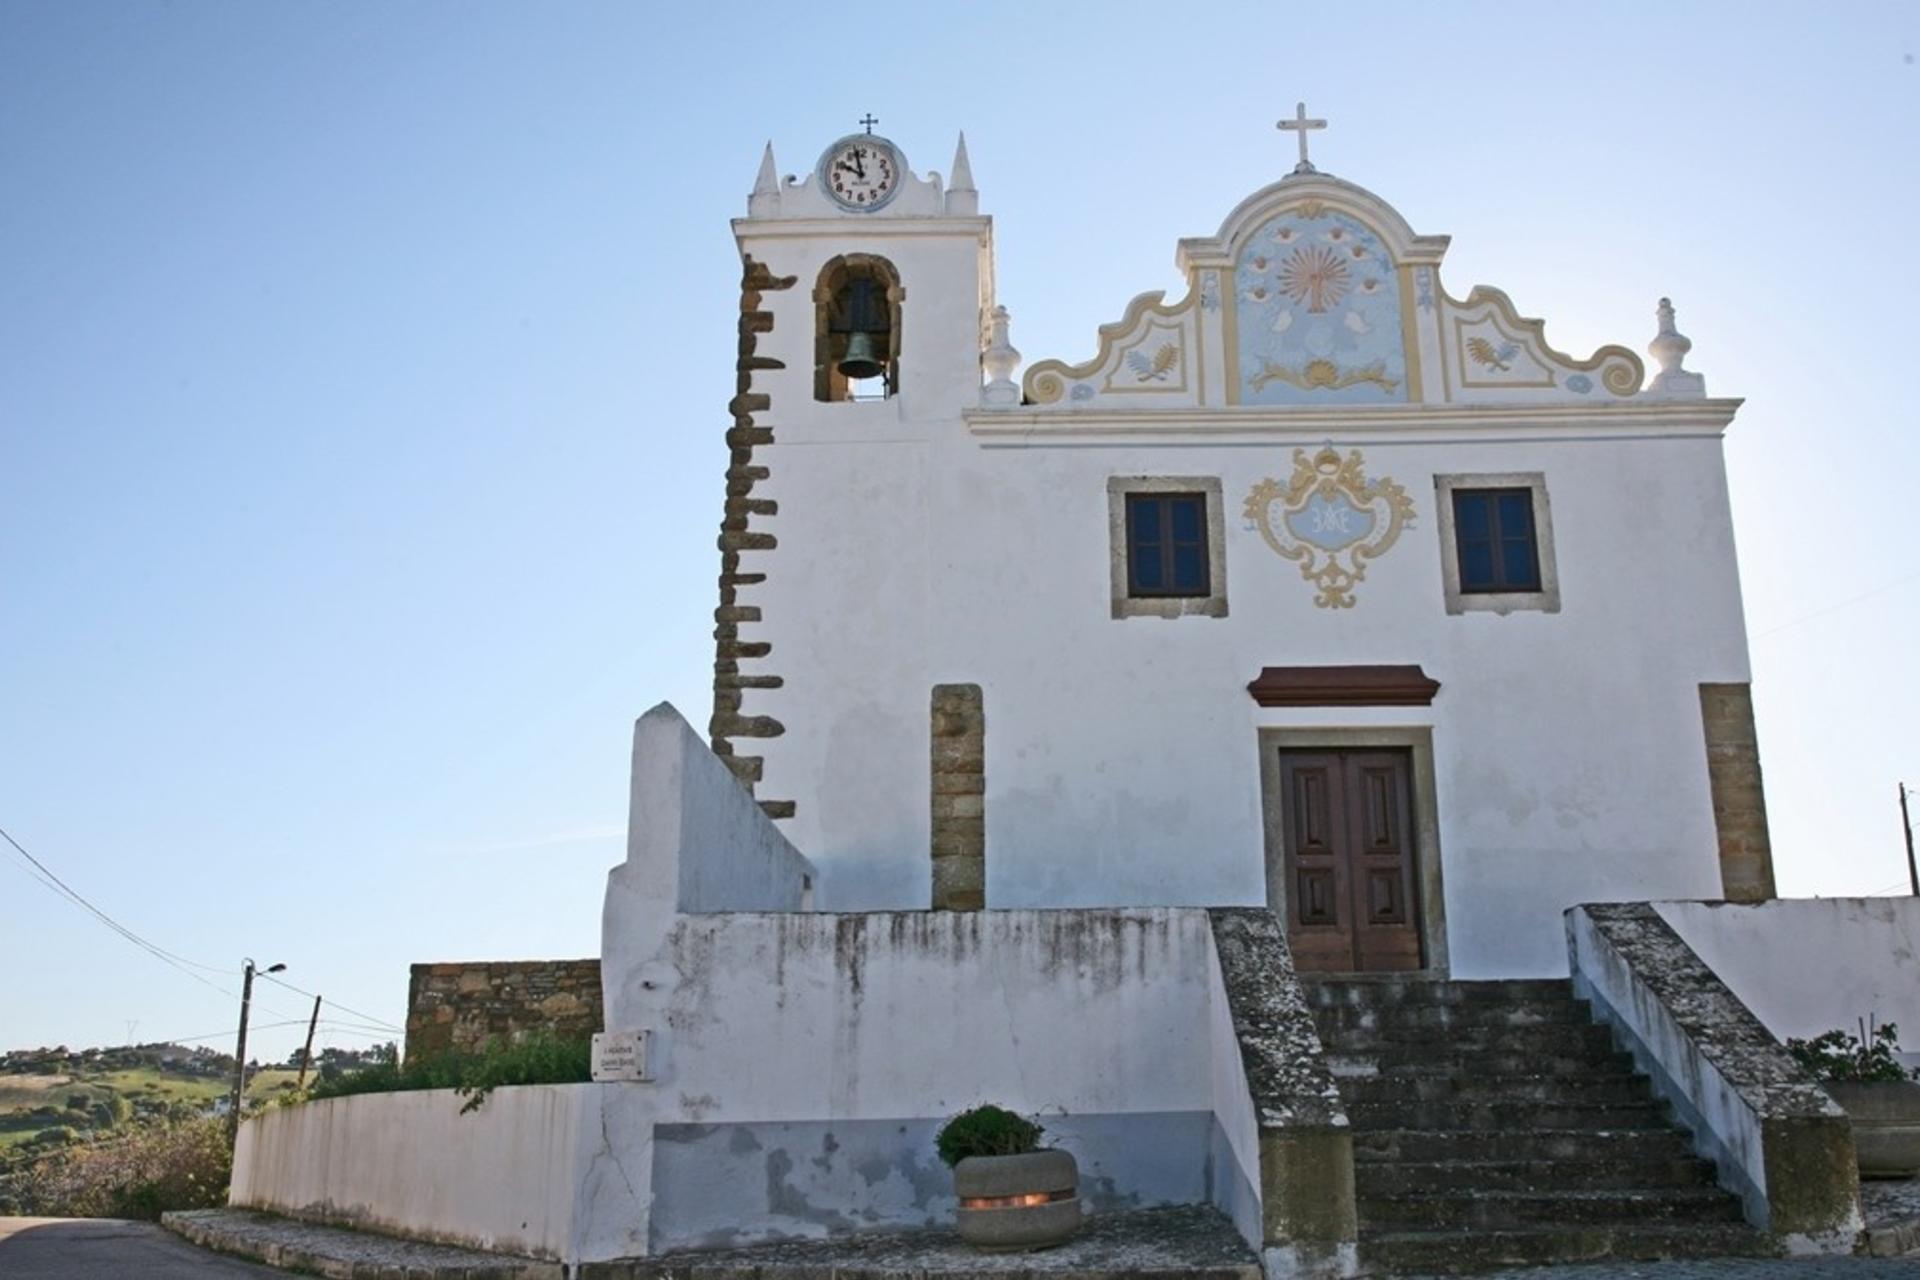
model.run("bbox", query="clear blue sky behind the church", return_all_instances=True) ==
[0,0,1920,1055]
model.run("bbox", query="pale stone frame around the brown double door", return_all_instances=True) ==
[1260,725,1452,977]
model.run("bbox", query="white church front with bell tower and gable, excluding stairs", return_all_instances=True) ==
[712,119,1772,977]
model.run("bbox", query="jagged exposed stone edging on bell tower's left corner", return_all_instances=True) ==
[707,255,793,818]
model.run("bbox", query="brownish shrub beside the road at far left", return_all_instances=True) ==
[23,1117,232,1219]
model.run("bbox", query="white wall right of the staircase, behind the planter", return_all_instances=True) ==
[1653,898,1920,1055]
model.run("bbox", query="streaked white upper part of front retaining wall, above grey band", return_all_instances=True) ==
[622,910,1213,1123]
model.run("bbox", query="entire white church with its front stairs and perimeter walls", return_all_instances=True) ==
[210,107,1920,1280]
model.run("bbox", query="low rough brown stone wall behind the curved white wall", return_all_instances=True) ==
[407,960,603,1057]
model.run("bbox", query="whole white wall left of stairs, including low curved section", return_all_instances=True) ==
[230,890,1260,1261]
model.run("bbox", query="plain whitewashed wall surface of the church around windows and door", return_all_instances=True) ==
[737,197,1749,977]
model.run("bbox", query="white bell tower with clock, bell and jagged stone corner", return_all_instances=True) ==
[708,115,995,871]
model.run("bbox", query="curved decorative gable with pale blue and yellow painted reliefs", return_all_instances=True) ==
[1023,173,1645,411]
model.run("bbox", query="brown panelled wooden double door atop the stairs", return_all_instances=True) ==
[1281,750,1421,973]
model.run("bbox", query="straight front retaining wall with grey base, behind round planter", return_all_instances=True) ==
[607,910,1228,1251]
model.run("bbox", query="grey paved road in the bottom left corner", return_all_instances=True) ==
[0,1219,286,1280]
